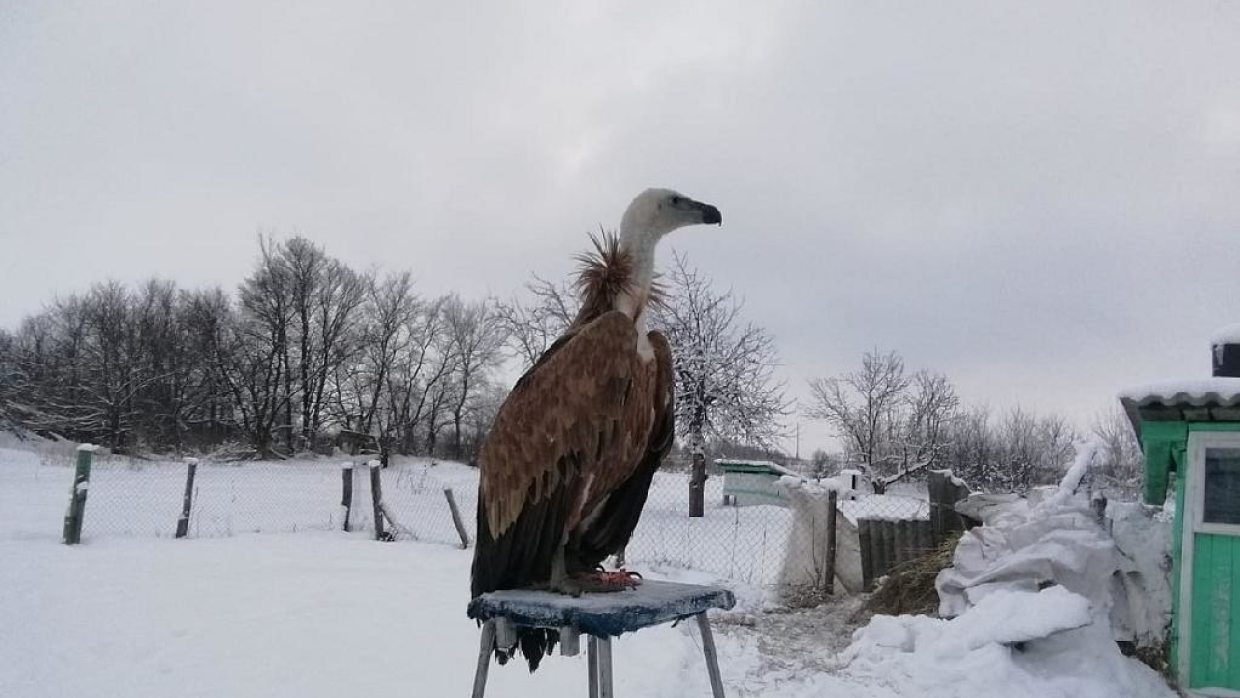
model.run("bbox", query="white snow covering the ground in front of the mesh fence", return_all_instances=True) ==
[0,449,1174,698]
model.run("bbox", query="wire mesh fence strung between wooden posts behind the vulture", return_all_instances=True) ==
[58,456,930,585]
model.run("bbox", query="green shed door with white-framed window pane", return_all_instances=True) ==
[1180,434,1240,696]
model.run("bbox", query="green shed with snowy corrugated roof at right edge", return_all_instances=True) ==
[1120,342,1240,698]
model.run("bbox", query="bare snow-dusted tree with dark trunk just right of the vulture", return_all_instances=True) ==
[653,254,787,517]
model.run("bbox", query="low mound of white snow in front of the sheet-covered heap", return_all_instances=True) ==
[841,586,1174,698]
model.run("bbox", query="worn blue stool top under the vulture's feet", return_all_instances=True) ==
[467,579,737,637]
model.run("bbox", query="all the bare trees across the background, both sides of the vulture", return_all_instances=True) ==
[0,231,1141,493]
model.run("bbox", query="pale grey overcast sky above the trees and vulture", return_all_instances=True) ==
[0,0,1240,453]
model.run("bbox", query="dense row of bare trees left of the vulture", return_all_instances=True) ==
[0,237,505,457]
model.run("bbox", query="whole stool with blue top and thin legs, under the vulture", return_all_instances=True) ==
[469,580,737,698]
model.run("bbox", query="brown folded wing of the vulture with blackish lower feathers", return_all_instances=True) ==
[472,311,655,595]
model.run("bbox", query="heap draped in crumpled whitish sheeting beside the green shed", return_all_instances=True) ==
[935,445,1171,646]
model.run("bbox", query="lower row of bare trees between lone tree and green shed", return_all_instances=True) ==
[806,351,1142,495]
